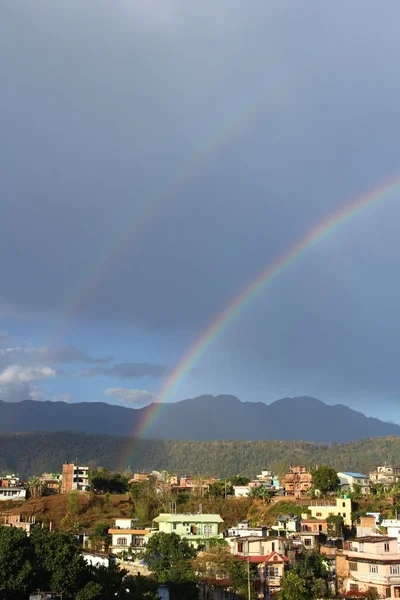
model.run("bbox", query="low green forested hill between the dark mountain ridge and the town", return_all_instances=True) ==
[0,432,400,477]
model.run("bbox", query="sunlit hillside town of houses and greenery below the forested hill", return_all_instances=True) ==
[0,463,400,600]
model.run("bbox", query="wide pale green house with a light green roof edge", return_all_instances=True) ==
[153,513,223,547]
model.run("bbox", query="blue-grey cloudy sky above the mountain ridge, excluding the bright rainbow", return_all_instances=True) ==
[0,0,400,423]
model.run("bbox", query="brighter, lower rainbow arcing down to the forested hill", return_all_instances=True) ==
[119,176,400,468]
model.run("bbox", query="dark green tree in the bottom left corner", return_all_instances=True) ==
[0,527,34,600]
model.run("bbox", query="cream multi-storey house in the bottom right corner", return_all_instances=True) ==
[340,536,400,598]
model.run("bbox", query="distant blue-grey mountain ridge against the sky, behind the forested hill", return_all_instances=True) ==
[0,395,400,443]
